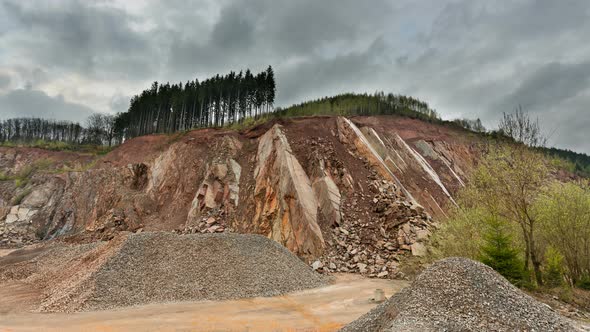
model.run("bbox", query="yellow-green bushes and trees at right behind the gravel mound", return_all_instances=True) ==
[433,145,590,294]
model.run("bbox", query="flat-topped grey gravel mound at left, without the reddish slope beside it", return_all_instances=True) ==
[62,232,327,311]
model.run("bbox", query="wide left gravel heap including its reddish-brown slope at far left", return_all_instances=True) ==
[13,232,330,312]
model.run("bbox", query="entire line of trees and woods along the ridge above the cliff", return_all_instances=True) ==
[0,66,590,177]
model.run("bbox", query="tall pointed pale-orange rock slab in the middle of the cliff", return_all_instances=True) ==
[252,125,325,257]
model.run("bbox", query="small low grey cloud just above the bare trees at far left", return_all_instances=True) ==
[0,89,93,122]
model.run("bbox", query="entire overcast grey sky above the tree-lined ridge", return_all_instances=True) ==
[0,0,590,153]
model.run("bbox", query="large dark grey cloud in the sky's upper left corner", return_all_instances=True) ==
[2,0,154,79]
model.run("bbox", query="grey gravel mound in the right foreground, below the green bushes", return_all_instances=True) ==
[341,258,575,332]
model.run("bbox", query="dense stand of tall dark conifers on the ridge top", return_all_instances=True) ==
[115,66,276,138]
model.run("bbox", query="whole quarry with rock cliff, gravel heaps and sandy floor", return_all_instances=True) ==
[0,116,588,331]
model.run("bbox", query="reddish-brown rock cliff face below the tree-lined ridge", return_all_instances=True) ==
[0,116,479,277]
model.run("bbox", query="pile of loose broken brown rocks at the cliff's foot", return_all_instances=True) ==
[313,179,435,278]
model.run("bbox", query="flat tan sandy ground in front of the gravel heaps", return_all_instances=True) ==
[0,274,408,332]
